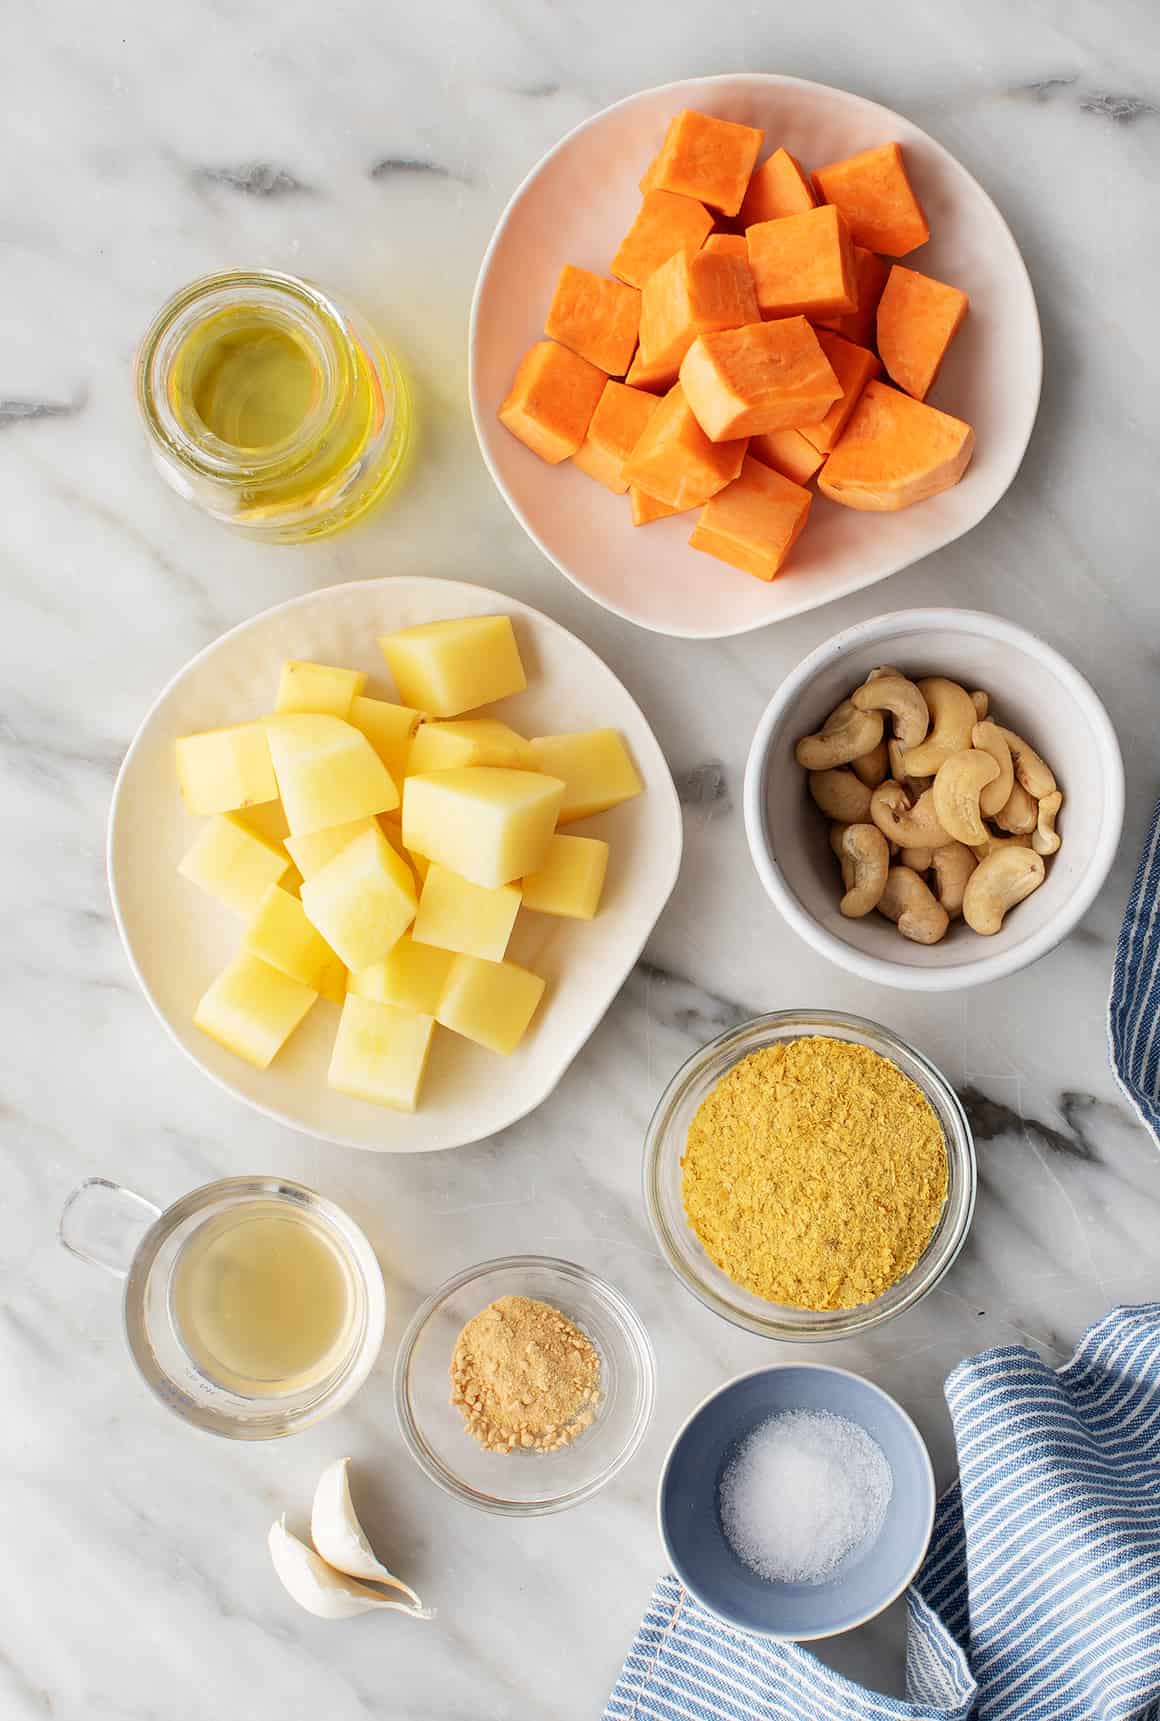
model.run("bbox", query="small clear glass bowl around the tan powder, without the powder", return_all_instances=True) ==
[394,1255,656,1518]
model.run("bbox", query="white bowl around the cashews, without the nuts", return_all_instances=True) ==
[744,609,1124,991]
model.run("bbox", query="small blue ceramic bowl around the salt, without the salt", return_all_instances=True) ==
[657,1363,935,1642]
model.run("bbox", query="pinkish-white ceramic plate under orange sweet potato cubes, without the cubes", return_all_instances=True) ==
[470,72,1043,638]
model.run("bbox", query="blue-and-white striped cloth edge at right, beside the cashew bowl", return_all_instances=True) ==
[1108,804,1160,1139]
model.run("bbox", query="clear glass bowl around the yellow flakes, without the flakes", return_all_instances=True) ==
[644,1010,976,1342]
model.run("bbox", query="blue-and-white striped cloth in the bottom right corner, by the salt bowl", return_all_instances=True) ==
[604,1303,1160,1721]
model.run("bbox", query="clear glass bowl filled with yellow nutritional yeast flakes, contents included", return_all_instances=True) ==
[644,1010,976,1342]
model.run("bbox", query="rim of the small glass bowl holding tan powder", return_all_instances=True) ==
[392,1255,656,1518]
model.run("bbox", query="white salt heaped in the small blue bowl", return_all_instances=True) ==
[721,1409,893,1583]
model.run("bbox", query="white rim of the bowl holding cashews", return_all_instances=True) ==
[742,608,1124,991]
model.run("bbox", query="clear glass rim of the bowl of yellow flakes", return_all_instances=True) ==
[640,1007,979,1342]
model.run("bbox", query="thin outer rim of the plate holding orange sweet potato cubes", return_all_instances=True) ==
[466,71,1043,640]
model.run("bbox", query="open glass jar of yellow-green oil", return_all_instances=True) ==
[136,268,411,544]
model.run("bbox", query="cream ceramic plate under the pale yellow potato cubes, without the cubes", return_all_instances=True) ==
[108,578,682,1153]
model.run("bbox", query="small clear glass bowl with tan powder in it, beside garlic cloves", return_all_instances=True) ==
[394,1255,656,1518]
